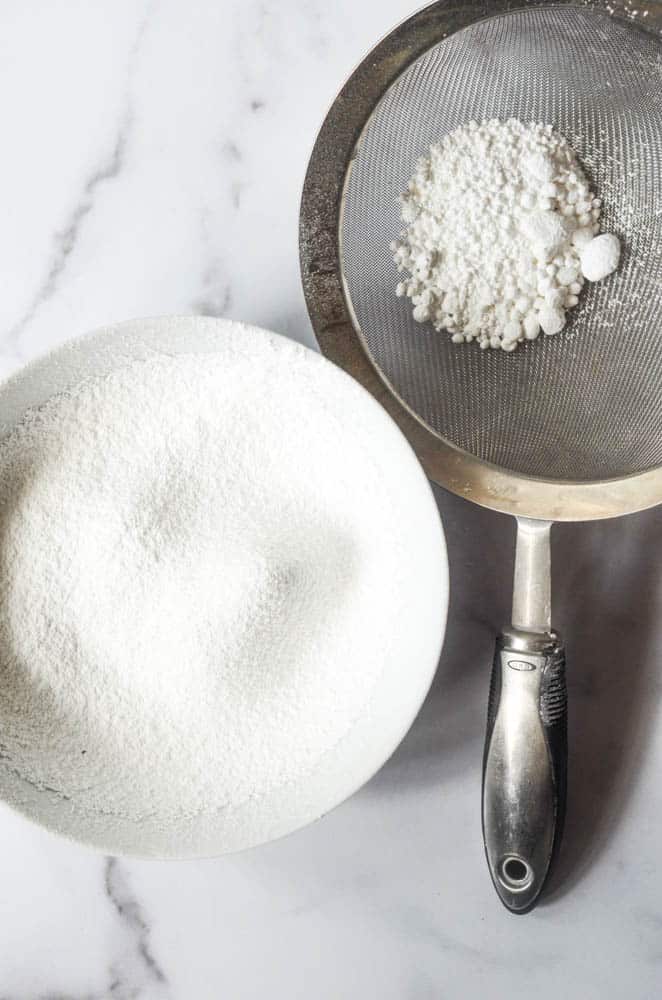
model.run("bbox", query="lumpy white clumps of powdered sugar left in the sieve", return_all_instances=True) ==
[391,119,618,351]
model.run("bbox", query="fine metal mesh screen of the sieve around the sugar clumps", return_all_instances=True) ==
[340,7,662,480]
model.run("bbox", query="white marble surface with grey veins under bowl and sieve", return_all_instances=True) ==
[0,0,662,1000]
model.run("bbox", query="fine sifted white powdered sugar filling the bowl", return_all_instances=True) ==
[0,325,444,847]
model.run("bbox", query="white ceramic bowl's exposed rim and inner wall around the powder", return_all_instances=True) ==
[0,317,448,858]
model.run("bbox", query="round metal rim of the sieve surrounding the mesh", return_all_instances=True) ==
[299,0,662,521]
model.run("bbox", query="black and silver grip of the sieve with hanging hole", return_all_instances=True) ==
[483,631,567,913]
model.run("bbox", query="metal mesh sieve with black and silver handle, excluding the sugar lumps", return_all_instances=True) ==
[300,0,662,913]
